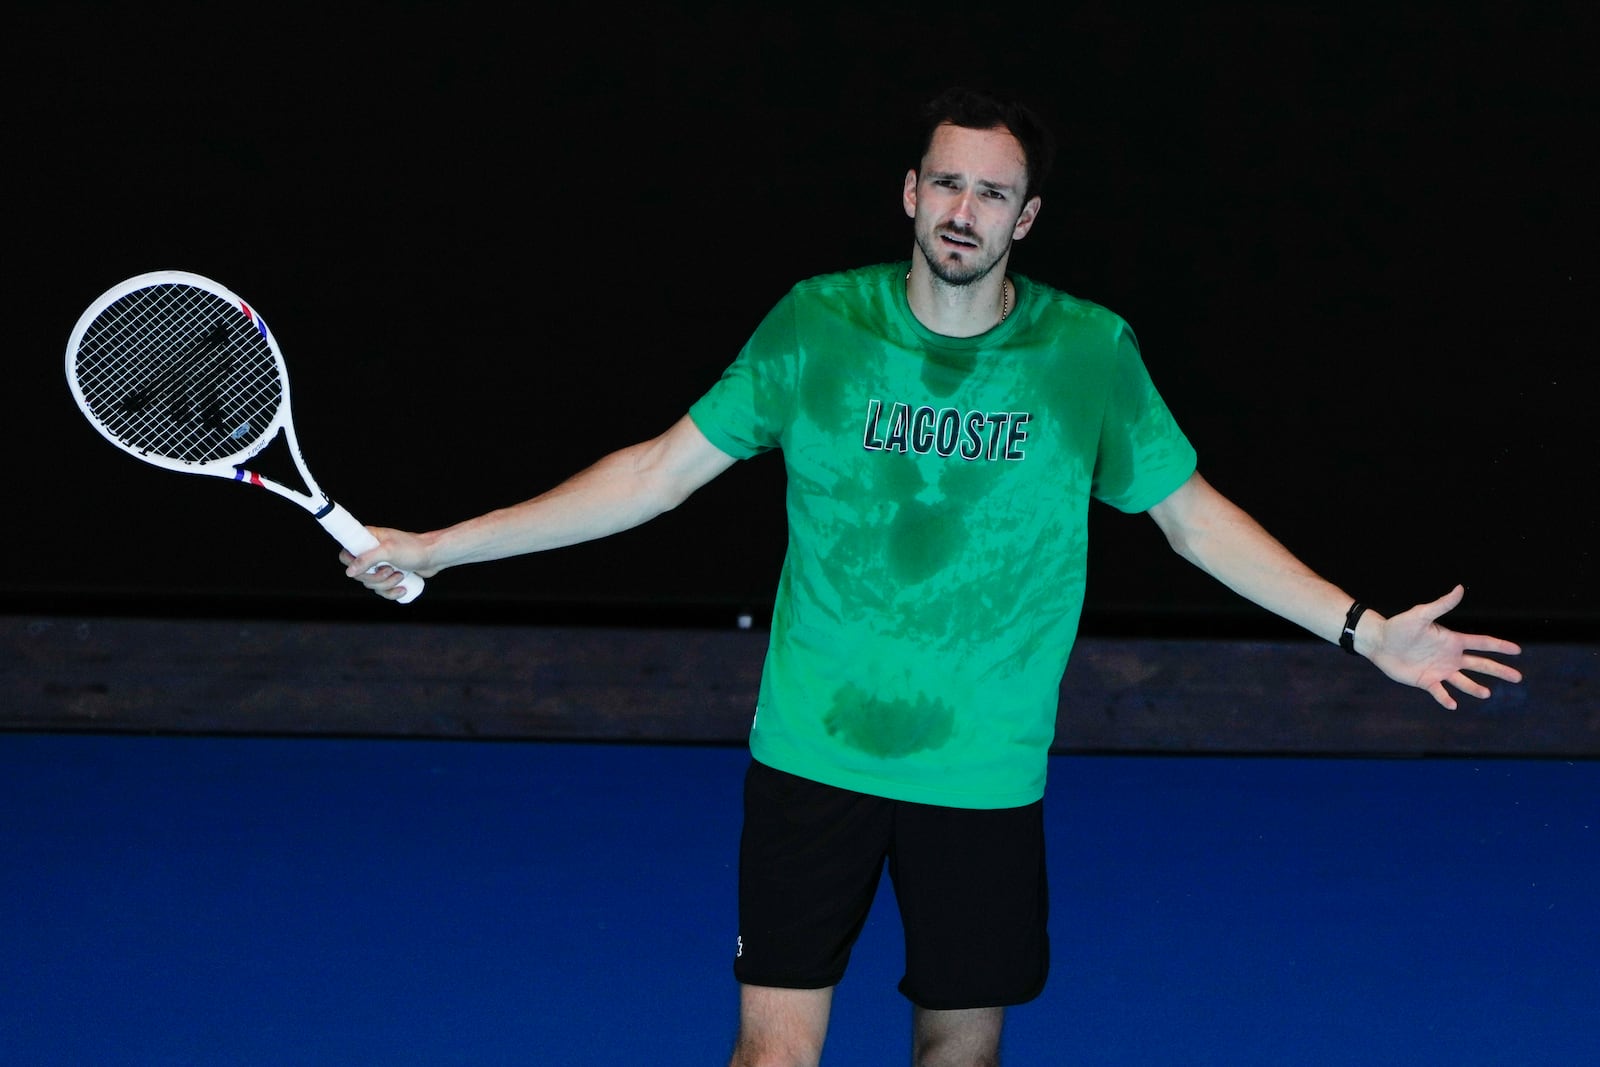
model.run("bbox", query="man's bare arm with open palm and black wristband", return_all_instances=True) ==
[1150,472,1522,709]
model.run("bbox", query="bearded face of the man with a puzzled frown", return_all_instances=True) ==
[902,123,1038,285]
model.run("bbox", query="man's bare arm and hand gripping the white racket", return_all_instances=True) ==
[339,416,734,600]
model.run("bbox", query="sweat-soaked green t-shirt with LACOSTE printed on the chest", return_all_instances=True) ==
[690,262,1195,808]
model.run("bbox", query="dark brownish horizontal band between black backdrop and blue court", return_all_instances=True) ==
[0,616,1600,757]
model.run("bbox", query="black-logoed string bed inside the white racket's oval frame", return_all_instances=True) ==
[74,283,283,462]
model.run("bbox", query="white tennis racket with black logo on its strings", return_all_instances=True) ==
[67,270,422,603]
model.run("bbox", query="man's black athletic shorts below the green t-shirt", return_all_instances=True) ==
[733,760,1050,1009]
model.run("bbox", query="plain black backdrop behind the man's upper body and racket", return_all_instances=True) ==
[0,3,1600,641]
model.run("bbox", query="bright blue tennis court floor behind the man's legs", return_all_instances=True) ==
[0,734,1600,1067]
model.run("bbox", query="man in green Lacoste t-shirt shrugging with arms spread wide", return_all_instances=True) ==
[341,90,1520,1067]
